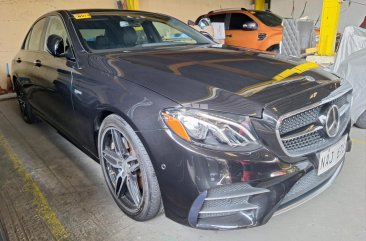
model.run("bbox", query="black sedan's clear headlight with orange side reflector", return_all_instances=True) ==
[161,108,258,150]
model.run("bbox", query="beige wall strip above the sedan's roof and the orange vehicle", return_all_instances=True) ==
[140,0,252,23]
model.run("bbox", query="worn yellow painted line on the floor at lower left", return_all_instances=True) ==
[0,134,69,240]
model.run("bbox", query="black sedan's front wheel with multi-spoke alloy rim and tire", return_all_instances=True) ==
[98,114,162,221]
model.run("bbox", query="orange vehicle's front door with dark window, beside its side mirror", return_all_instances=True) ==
[225,13,258,49]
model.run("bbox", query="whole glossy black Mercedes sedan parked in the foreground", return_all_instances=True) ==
[12,10,352,229]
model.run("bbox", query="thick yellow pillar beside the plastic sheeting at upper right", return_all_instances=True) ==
[318,0,343,56]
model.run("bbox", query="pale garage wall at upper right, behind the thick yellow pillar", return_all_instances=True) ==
[271,0,366,32]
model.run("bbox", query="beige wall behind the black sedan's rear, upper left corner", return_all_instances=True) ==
[0,0,117,88]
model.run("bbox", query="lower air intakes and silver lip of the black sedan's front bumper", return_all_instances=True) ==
[189,158,344,229]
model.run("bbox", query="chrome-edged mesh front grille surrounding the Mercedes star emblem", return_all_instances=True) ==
[277,87,351,156]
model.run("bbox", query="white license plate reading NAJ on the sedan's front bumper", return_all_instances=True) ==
[318,135,347,175]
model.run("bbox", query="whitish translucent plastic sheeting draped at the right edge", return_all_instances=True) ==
[334,27,366,123]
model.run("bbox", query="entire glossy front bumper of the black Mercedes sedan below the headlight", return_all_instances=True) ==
[141,116,351,229]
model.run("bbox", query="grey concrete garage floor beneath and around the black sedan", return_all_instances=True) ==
[0,95,366,241]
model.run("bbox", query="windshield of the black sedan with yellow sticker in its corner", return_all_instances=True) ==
[73,12,212,52]
